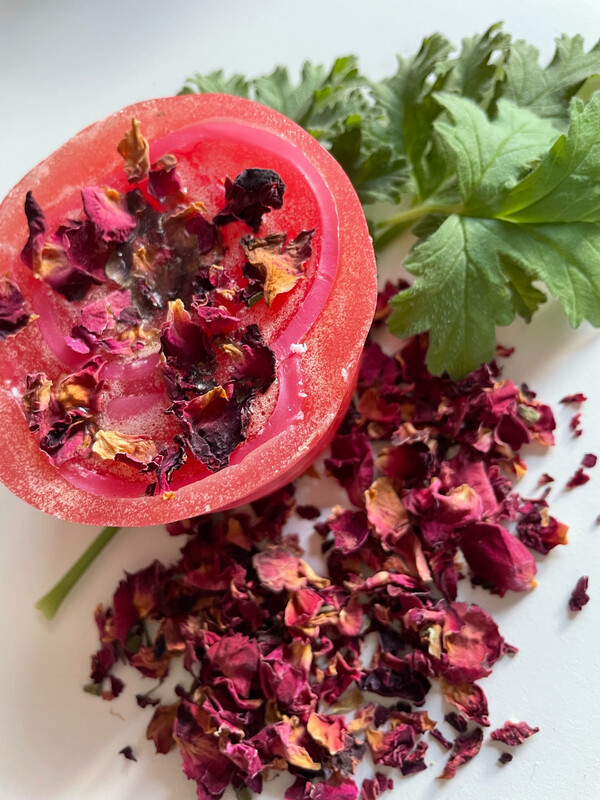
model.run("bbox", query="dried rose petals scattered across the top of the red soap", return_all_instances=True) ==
[17,119,304,499]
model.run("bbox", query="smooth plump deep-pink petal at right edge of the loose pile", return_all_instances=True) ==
[460,523,537,595]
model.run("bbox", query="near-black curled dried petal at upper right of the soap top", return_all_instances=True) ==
[213,168,285,232]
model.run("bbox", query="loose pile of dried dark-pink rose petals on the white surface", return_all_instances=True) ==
[88,301,566,800]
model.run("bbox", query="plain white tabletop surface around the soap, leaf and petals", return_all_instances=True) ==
[0,0,600,800]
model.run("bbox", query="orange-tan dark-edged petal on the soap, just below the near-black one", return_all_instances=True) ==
[241,233,315,306]
